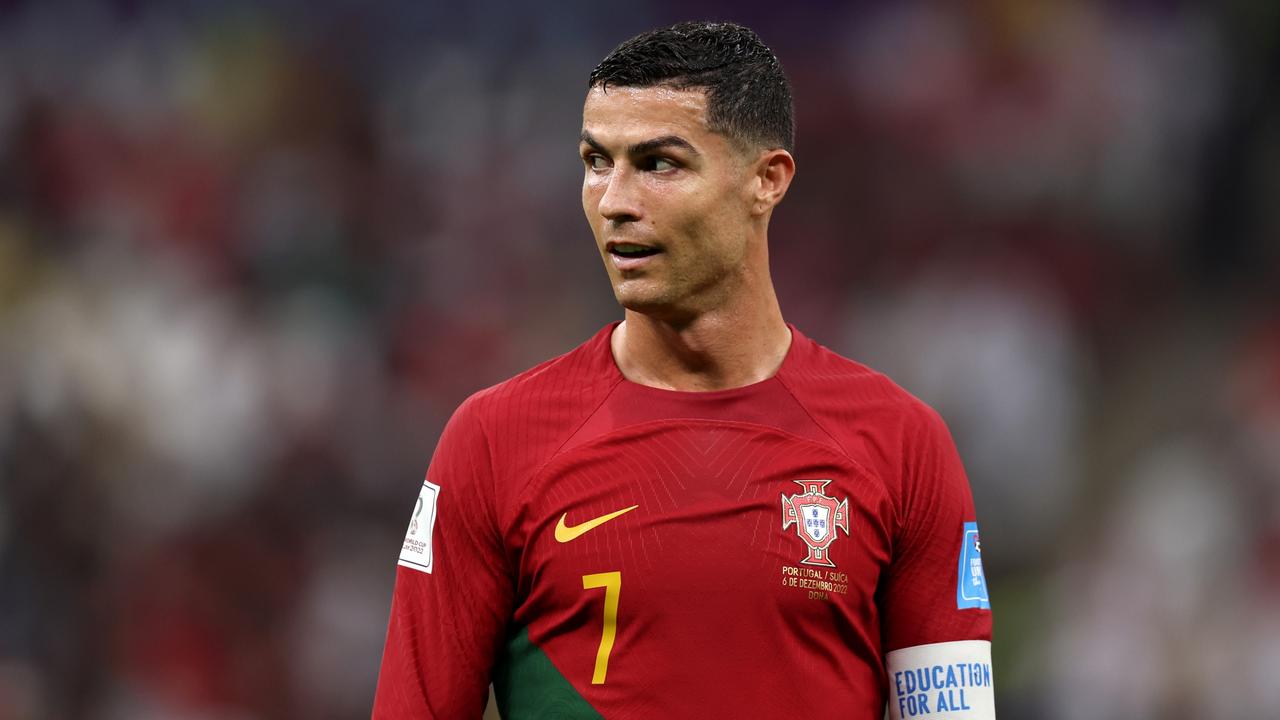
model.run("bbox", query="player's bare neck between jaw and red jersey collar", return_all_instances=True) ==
[611,292,791,392]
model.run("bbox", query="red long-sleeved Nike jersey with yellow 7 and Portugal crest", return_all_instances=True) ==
[374,325,991,720]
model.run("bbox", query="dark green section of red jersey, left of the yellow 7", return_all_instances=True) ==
[493,628,603,720]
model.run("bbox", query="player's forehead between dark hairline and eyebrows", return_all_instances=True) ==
[582,86,716,145]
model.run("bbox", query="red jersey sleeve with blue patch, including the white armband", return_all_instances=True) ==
[881,405,995,720]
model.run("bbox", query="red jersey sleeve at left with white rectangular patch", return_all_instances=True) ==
[372,401,513,720]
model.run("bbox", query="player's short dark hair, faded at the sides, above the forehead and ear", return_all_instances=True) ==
[588,22,795,152]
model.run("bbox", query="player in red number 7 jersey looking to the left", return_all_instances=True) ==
[374,23,995,720]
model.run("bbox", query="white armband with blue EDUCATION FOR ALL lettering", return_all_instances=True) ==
[884,641,996,720]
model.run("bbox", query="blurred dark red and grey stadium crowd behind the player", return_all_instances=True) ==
[0,0,1280,720]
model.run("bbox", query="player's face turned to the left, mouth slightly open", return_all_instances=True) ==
[579,86,751,319]
